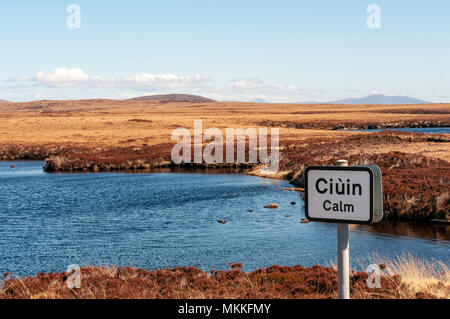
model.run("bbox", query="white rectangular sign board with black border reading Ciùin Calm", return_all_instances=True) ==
[305,166,381,224]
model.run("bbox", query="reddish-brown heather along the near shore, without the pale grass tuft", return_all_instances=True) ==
[0,263,401,299]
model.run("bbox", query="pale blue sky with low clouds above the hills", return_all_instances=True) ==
[0,0,450,102]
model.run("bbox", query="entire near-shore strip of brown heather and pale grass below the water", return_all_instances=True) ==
[0,256,450,299]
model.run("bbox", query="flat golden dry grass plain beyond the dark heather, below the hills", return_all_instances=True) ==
[0,100,450,160]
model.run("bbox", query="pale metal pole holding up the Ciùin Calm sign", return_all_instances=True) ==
[337,160,350,299]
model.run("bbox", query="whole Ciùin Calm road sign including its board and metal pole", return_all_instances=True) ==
[305,160,383,299]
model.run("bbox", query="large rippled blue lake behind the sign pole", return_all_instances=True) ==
[0,162,450,276]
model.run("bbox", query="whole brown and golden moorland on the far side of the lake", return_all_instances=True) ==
[0,100,450,221]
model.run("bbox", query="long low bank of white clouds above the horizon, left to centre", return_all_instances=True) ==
[3,67,304,101]
